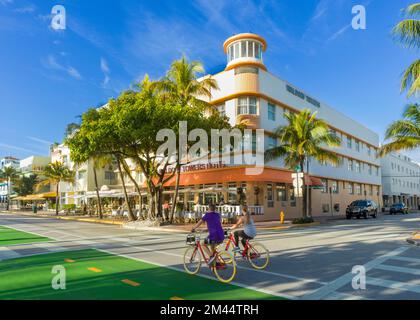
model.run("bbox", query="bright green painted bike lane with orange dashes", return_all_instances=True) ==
[0,220,280,300]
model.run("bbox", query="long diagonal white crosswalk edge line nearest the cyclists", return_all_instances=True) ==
[303,246,410,300]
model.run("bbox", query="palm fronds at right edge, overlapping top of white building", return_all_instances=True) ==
[379,103,420,156]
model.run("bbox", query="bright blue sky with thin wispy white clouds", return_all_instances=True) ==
[0,0,420,162]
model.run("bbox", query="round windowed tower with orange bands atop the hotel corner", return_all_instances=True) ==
[223,33,267,70]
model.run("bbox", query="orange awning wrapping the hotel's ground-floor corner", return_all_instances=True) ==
[166,167,322,186]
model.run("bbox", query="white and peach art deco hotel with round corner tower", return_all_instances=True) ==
[168,33,382,220]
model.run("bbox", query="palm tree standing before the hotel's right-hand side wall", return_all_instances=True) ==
[265,109,341,217]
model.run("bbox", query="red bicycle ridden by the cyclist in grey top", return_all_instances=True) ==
[225,229,270,270]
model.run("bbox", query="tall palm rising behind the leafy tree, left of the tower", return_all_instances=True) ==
[151,56,219,223]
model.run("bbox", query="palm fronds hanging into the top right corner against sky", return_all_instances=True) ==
[393,3,420,97]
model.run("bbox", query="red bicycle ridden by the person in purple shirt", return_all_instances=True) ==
[184,233,236,283]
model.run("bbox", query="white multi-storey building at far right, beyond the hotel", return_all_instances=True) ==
[381,153,420,209]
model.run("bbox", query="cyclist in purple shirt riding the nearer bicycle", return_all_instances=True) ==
[191,204,225,264]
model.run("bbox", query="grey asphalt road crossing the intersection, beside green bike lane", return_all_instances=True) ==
[0,213,420,300]
